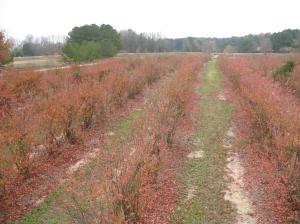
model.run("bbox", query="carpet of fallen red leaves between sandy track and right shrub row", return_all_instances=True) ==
[224,75,299,224]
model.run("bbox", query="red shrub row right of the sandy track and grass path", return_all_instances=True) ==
[219,53,300,222]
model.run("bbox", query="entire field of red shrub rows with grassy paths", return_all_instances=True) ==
[0,53,300,224]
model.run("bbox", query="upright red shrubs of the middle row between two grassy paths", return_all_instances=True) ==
[99,56,206,223]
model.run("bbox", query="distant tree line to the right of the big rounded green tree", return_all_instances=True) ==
[120,29,300,53]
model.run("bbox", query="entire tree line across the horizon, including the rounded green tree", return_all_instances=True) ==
[0,24,300,64]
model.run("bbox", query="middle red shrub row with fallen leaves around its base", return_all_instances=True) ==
[56,53,207,223]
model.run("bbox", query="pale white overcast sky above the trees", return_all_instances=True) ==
[0,0,300,39]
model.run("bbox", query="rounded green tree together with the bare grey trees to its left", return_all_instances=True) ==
[12,24,121,61]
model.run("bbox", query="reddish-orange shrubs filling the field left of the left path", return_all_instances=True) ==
[0,56,177,194]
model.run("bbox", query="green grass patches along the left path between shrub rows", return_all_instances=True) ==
[15,110,142,224]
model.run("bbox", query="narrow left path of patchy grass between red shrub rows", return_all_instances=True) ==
[11,69,173,224]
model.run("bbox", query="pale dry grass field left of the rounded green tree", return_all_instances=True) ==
[9,55,64,68]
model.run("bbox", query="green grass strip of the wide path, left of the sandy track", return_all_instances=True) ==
[173,62,233,224]
